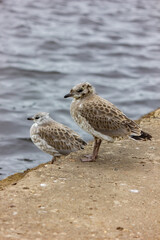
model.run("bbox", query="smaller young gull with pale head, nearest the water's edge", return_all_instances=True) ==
[28,112,87,163]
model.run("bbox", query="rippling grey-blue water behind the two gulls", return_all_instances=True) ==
[0,0,160,179]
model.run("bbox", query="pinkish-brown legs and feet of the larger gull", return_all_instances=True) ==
[81,137,102,162]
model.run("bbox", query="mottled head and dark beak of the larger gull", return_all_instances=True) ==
[64,82,95,99]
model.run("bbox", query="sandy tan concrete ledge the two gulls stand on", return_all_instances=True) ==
[0,109,160,240]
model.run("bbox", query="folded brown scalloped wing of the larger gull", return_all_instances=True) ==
[78,95,141,137]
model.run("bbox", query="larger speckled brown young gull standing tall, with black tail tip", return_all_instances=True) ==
[64,82,152,162]
